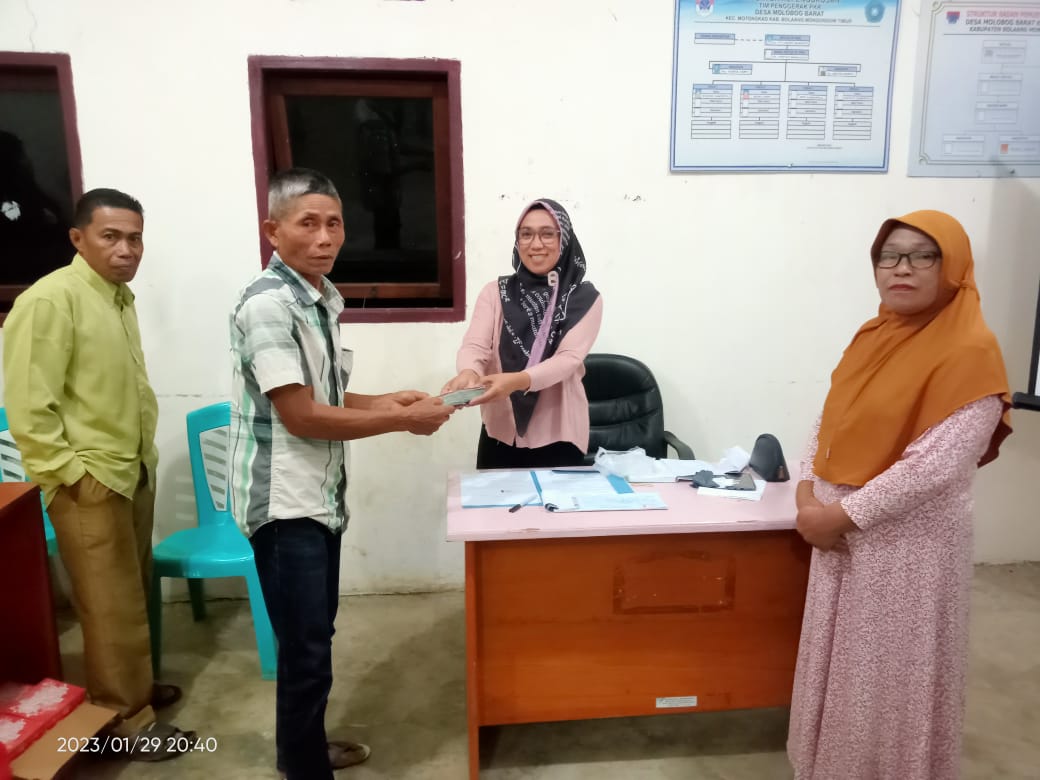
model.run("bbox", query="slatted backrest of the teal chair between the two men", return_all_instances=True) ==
[187,401,235,525]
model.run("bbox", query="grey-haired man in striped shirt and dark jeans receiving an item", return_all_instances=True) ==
[231,168,453,780]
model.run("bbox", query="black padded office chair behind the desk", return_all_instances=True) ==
[581,354,694,463]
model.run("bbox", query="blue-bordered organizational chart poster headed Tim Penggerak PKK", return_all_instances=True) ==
[671,0,899,171]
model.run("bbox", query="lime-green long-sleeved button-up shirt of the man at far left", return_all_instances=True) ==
[3,255,158,503]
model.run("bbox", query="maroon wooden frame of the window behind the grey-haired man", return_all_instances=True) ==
[249,55,466,322]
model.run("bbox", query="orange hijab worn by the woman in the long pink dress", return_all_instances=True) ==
[813,211,1011,486]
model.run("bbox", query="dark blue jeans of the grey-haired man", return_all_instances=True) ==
[250,518,341,780]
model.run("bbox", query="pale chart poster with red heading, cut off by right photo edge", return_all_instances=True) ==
[909,0,1040,177]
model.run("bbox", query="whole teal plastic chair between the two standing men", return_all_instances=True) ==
[149,402,278,680]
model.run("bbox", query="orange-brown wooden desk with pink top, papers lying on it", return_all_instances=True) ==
[447,474,811,780]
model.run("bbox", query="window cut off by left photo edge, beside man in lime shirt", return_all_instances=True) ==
[0,52,83,320]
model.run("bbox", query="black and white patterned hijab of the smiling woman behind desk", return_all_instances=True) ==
[498,198,599,436]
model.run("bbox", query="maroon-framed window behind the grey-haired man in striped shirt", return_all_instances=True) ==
[250,56,465,322]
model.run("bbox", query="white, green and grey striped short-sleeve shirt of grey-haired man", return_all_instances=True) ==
[230,254,349,536]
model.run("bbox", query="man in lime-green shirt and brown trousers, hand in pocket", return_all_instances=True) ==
[3,189,193,760]
